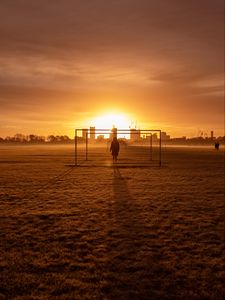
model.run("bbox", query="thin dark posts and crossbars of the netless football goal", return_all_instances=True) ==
[74,128,162,167]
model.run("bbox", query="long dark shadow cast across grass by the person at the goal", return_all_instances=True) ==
[104,166,162,299]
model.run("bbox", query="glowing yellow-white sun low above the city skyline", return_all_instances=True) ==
[92,113,130,129]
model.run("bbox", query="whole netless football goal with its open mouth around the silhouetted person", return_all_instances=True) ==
[74,127,162,167]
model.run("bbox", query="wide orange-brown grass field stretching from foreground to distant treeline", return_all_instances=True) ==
[0,146,225,299]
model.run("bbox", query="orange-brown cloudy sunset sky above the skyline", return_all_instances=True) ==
[0,0,224,137]
